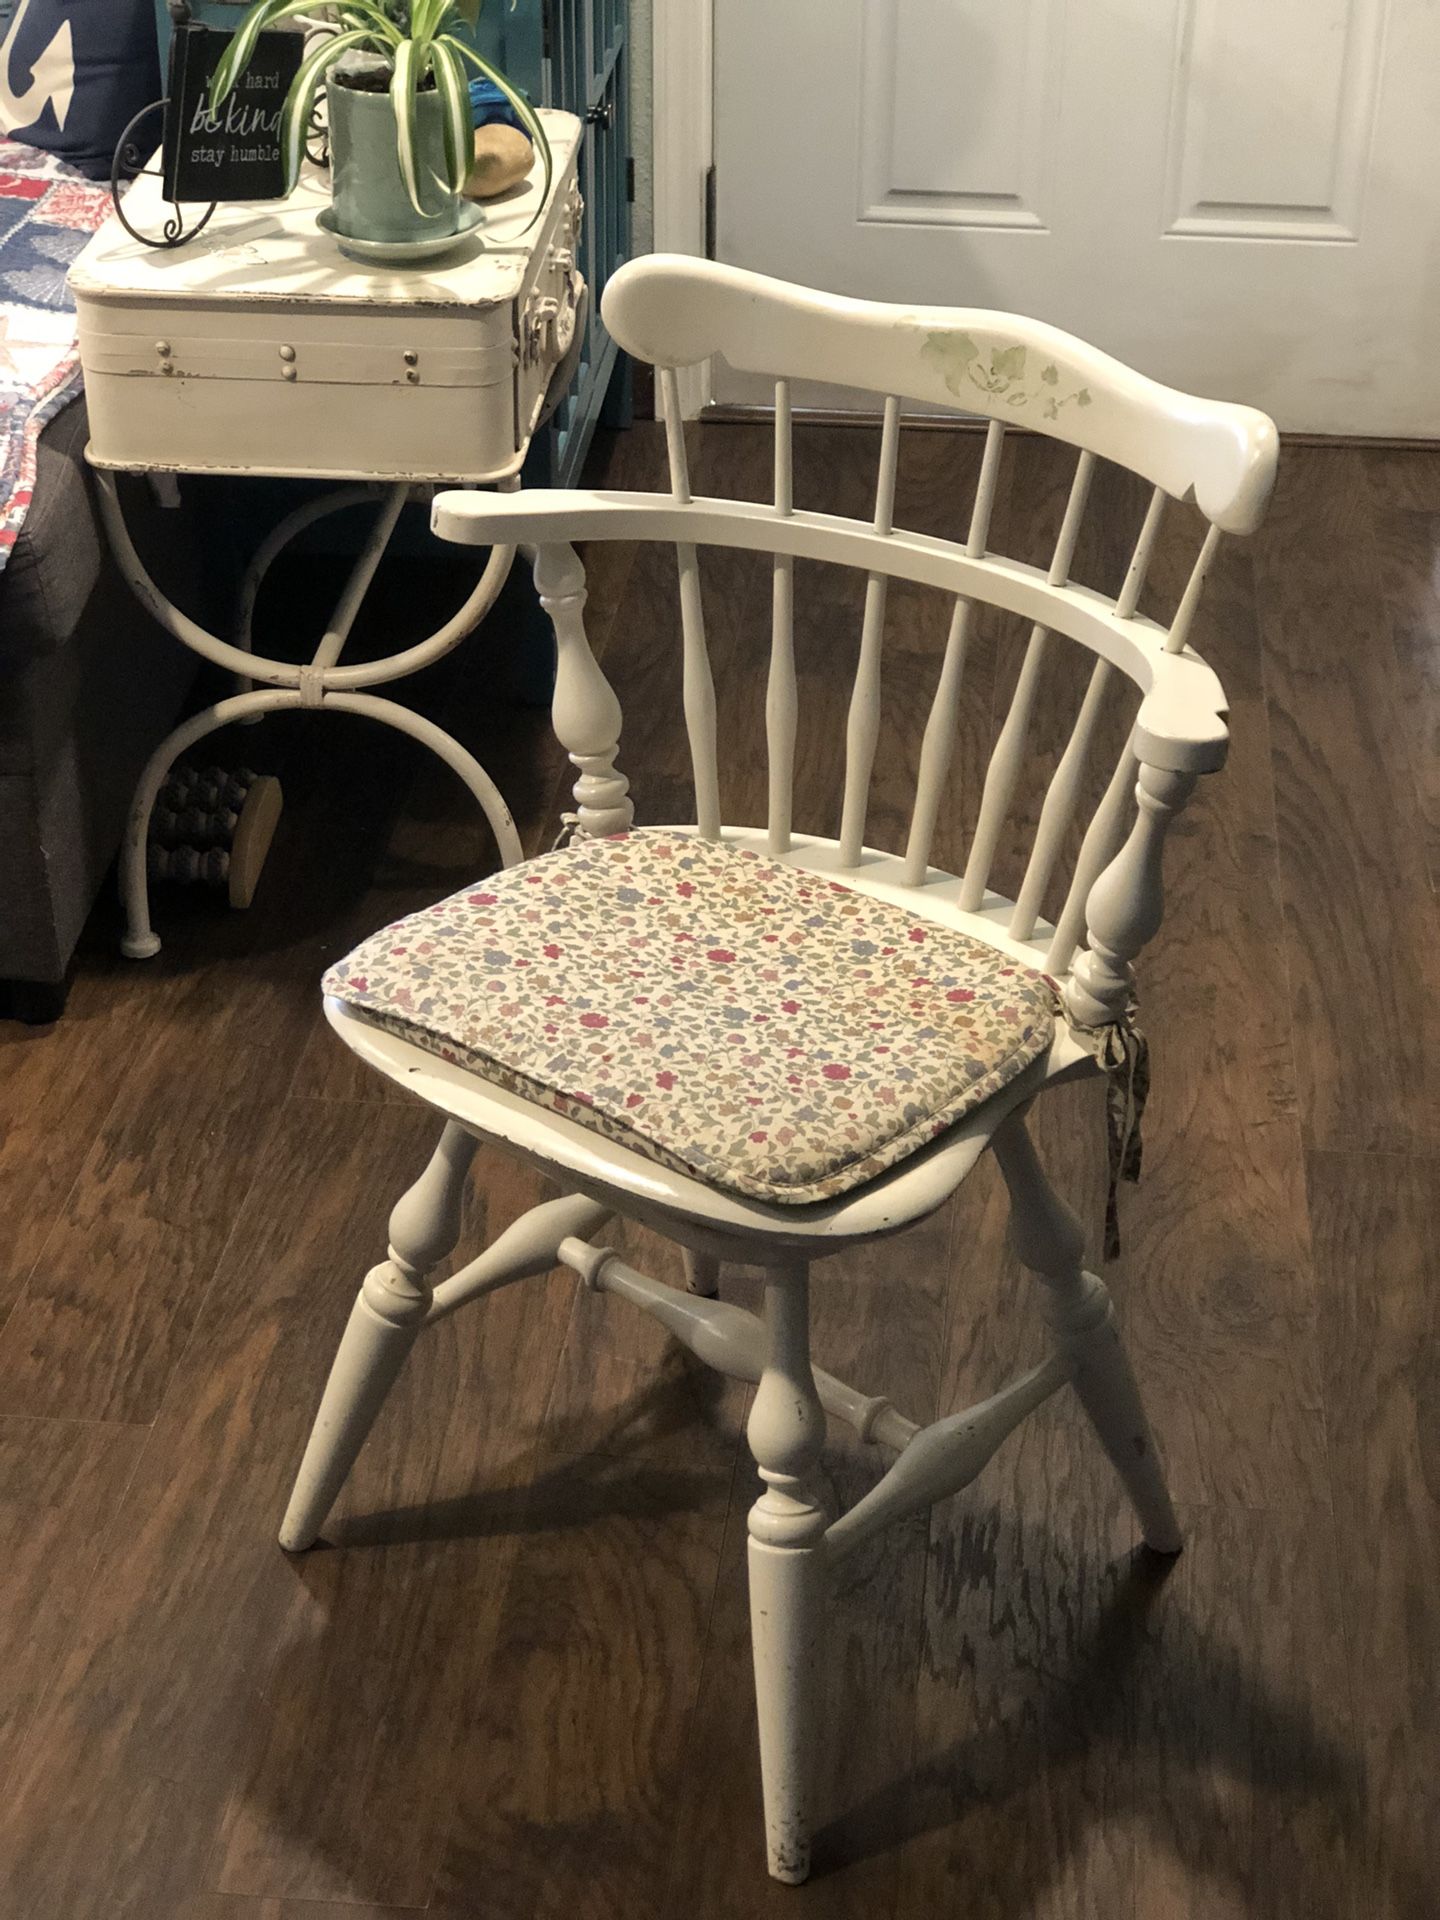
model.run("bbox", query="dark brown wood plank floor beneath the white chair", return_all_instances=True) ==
[0,426,1440,1920]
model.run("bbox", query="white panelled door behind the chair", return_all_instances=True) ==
[714,0,1440,436]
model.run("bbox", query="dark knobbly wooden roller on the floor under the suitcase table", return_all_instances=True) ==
[146,766,284,906]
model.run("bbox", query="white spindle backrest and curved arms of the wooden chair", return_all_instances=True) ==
[434,255,1277,1023]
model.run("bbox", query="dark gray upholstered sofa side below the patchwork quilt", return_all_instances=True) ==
[0,399,213,1021]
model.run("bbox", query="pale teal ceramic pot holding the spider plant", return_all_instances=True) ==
[326,77,459,242]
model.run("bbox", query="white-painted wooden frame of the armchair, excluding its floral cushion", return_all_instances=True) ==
[294,259,1275,1882]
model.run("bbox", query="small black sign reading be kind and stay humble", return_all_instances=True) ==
[163,25,305,200]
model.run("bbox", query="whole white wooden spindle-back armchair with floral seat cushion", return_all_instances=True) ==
[280,257,1277,1882]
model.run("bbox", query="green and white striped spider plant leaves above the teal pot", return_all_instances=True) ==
[209,0,551,215]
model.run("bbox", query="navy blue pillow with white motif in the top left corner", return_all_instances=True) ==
[0,0,161,180]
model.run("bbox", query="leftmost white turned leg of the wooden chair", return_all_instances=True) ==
[280,1121,478,1553]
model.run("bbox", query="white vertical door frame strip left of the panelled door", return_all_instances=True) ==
[653,0,714,420]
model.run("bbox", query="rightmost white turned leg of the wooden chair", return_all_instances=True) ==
[993,1116,1181,1553]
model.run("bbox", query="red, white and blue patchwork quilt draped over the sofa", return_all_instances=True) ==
[0,138,109,570]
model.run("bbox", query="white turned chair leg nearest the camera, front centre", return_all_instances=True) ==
[745,1261,828,1885]
